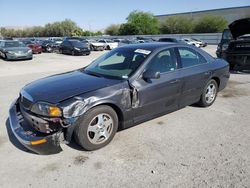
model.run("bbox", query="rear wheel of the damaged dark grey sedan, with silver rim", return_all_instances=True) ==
[198,79,218,107]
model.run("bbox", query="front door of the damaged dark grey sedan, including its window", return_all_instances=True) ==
[132,48,181,122]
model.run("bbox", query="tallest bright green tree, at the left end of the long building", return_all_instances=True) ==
[119,11,159,35]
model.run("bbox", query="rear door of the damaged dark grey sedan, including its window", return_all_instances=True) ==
[176,47,212,107]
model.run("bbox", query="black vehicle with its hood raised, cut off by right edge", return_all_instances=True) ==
[216,18,250,69]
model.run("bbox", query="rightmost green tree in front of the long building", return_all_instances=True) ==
[194,16,228,33]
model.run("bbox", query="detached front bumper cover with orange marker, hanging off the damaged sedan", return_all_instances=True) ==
[9,102,62,155]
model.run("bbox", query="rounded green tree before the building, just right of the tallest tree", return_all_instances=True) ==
[160,16,193,34]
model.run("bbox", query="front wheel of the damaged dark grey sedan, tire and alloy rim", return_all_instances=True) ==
[74,105,118,151]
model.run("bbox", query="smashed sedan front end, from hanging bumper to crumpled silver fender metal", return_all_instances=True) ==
[9,95,85,155]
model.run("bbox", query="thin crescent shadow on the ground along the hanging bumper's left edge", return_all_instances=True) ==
[5,118,37,155]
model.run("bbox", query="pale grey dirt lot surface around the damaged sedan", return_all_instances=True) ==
[0,46,250,188]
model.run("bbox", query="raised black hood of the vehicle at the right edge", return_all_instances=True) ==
[228,18,250,39]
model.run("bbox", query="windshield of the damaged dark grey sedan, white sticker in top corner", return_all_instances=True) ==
[85,48,151,79]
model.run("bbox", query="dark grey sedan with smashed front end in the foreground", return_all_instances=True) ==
[9,43,230,154]
